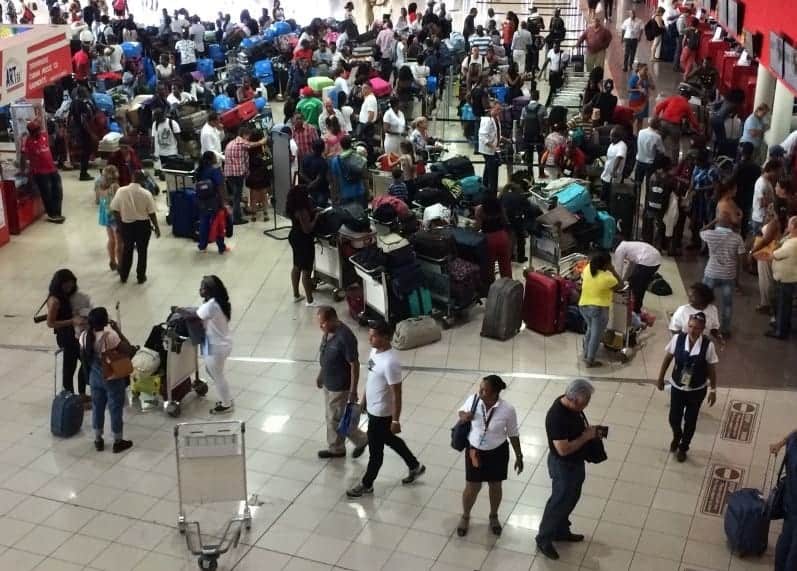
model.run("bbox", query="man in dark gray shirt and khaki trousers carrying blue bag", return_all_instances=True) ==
[316,306,368,459]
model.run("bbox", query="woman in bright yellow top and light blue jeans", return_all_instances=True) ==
[578,252,623,367]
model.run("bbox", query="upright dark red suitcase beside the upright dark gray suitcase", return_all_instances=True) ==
[523,272,567,335]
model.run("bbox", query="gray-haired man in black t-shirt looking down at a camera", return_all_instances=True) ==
[536,379,609,559]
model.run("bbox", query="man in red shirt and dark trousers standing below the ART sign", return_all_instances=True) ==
[22,120,66,224]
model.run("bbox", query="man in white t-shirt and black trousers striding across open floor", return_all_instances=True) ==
[346,321,426,498]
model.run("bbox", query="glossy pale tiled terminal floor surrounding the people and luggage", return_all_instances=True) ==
[0,2,797,571]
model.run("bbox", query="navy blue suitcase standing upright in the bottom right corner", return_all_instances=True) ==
[725,488,770,557]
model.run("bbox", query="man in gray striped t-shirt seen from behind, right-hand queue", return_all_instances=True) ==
[700,213,745,339]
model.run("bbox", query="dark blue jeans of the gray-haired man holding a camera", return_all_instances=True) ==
[536,452,586,544]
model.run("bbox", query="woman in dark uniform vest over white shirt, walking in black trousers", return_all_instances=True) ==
[658,311,719,462]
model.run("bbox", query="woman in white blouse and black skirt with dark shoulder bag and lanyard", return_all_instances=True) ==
[457,375,523,537]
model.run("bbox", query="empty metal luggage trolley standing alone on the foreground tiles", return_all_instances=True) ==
[174,421,252,571]
